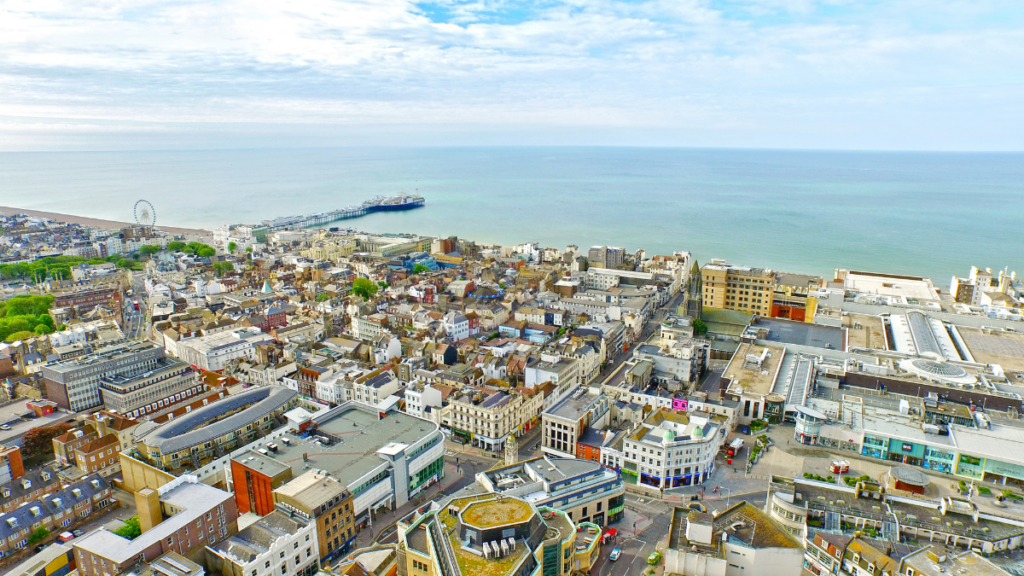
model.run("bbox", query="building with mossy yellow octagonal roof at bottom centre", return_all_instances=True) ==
[397,487,601,576]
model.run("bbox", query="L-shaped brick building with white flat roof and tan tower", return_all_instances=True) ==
[74,477,239,576]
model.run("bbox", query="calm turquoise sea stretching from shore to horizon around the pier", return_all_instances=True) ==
[0,147,1024,288]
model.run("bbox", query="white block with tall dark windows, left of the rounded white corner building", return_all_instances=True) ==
[541,387,611,457]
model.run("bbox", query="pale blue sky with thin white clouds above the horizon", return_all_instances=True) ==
[0,0,1024,151]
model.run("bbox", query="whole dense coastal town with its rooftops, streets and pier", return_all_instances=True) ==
[0,204,1024,576]
